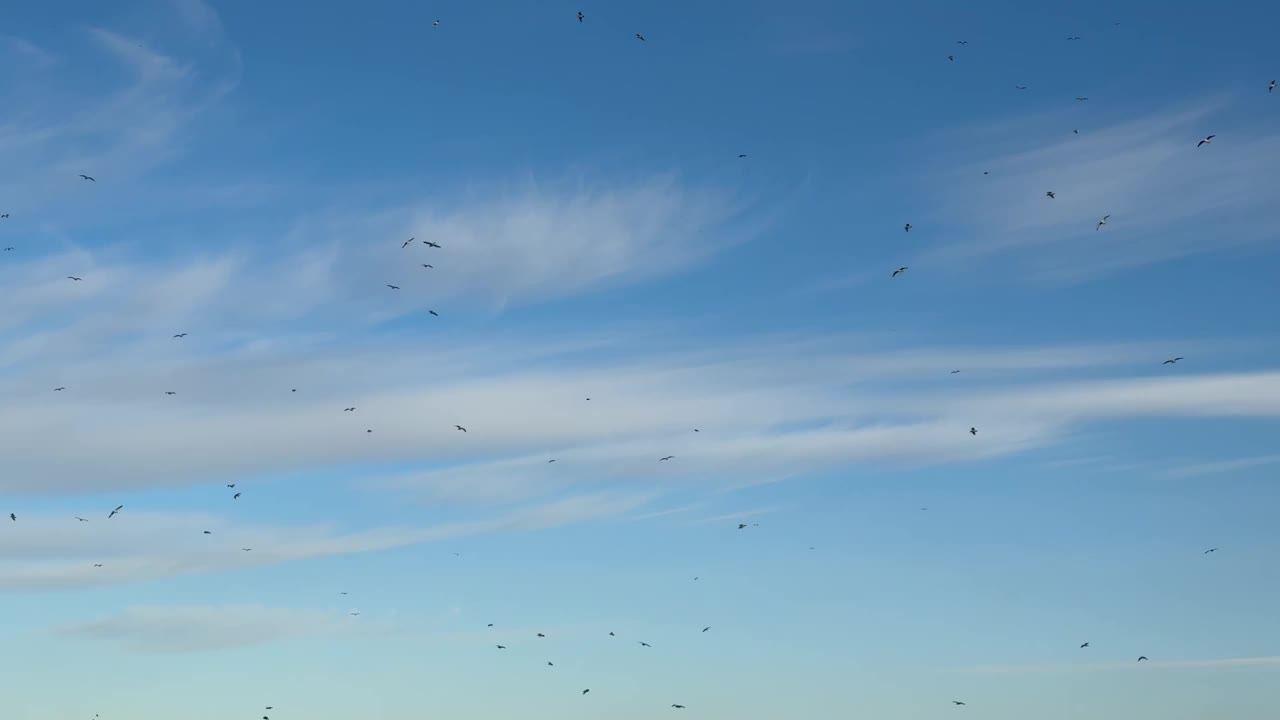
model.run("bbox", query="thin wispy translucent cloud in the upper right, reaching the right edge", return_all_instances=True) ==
[911,100,1280,282]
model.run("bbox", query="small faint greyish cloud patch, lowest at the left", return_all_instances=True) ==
[55,606,369,655]
